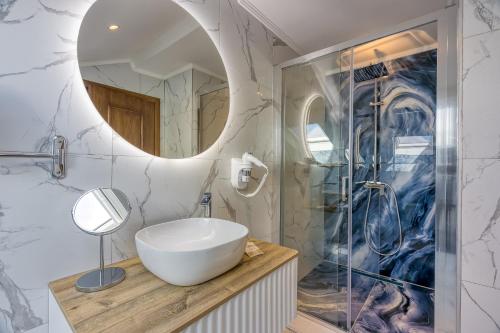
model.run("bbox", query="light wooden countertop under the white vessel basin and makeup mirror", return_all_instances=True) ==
[49,240,297,333]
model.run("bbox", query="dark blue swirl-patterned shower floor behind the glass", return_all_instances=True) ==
[298,261,434,333]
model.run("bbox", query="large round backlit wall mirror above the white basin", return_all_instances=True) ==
[78,0,229,158]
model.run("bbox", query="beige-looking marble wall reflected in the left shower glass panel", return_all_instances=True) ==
[281,66,325,280]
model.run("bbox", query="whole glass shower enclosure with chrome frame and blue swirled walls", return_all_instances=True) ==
[277,8,458,332]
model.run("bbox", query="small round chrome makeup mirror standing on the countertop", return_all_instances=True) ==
[72,188,132,293]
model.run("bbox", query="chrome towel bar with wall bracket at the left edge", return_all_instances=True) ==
[0,135,67,179]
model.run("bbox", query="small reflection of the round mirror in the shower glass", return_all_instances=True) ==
[304,95,333,164]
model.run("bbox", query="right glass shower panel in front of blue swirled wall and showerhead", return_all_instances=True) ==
[351,23,437,332]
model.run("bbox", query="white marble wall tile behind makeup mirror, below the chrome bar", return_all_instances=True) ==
[0,156,111,332]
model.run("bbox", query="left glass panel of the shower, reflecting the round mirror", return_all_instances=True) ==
[281,52,350,329]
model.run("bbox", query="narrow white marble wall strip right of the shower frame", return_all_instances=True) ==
[461,0,500,333]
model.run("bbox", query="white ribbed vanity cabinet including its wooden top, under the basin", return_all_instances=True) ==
[49,240,297,333]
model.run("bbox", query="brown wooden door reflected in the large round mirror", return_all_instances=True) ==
[84,80,160,156]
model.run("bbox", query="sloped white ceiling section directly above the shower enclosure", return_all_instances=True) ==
[239,0,450,54]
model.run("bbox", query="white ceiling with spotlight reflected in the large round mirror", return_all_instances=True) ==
[78,0,226,78]
